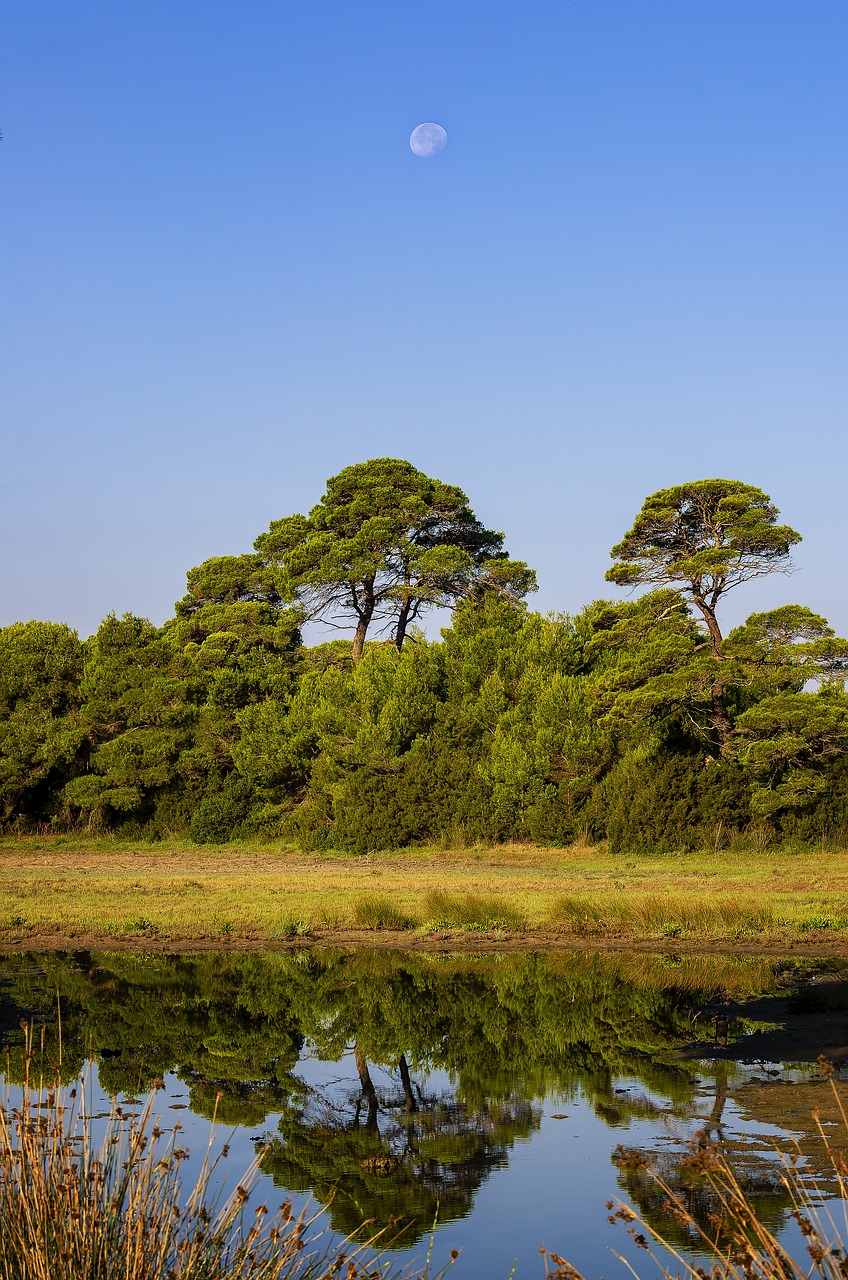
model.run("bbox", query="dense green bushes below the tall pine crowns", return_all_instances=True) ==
[0,586,848,854]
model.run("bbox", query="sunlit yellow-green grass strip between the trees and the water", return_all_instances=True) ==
[0,836,848,950]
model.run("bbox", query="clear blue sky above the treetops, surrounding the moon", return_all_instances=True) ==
[0,0,848,635]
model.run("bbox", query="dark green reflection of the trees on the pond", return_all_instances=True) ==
[0,950,845,1244]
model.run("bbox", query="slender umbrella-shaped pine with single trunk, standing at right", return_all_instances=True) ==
[606,480,801,746]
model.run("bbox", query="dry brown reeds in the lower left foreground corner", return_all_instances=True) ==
[0,1034,443,1280]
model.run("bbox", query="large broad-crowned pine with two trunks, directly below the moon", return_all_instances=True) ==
[254,458,535,662]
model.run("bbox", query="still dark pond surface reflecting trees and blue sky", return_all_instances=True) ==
[0,950,848,1280]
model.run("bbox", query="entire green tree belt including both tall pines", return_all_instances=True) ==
[0,458,848,854]
